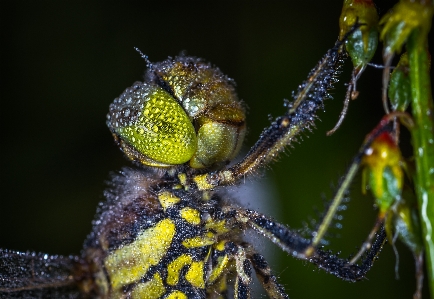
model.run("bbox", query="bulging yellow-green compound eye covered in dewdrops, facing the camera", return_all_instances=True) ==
[108,82,197,166]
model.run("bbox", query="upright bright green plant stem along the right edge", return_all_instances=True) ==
[407,29,434,298]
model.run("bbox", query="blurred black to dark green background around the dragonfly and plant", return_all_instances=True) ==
[0,1,426,298]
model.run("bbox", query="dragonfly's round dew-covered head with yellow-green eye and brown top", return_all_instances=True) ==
[107,56,245,168]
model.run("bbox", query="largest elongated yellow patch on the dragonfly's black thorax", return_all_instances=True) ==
[104,219,176,289]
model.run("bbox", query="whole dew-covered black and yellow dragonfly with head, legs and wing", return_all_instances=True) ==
[0,34,384,299]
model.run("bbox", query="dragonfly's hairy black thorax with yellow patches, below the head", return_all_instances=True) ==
[84,169,284,299]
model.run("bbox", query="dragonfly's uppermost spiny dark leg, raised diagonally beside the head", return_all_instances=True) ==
[193,35,345,190]
